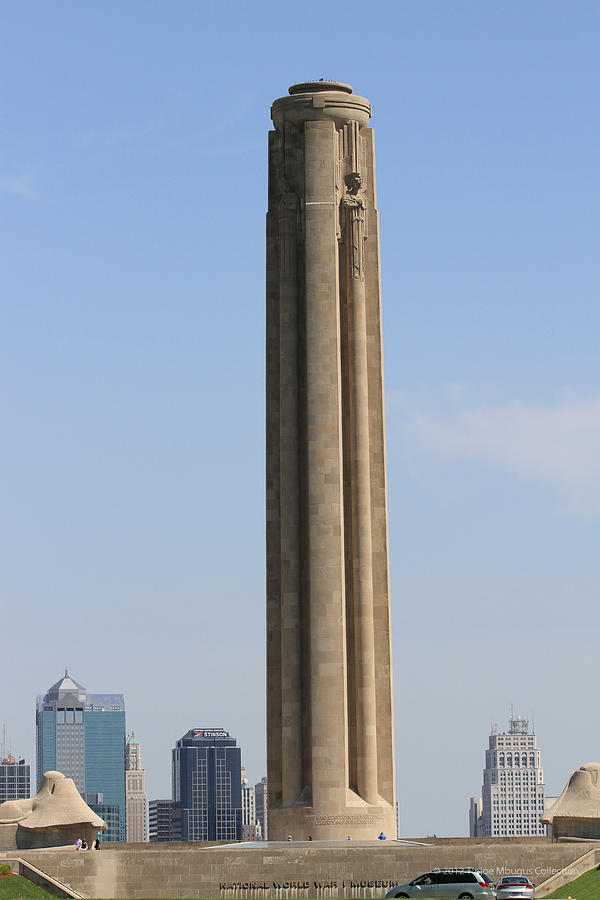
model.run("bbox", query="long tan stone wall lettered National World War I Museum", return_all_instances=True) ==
[5,838,597,900]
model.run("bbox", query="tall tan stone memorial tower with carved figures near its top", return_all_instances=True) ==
[267,81,395,840]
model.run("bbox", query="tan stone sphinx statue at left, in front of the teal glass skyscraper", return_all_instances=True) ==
[0,772,107,850]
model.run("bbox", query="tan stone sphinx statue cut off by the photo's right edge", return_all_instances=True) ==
[541,763,600,840]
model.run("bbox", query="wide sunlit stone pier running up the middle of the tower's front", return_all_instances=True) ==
[304,121,347,806]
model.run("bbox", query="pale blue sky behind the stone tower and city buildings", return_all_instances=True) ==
[0,0,600,836]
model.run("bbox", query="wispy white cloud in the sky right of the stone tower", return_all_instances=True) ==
[402,392,600,515]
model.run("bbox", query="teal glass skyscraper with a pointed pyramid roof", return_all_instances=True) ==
[36,670,126,842]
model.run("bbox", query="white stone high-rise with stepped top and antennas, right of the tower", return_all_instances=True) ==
[478,716,546,837]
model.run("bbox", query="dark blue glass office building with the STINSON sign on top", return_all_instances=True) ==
[173,728,242,841]
